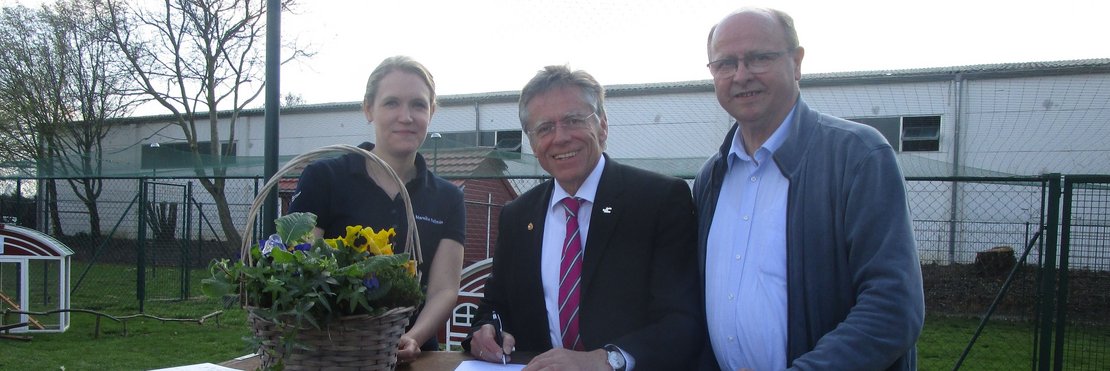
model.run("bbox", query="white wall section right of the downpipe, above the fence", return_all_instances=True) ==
[961,74,1110,176]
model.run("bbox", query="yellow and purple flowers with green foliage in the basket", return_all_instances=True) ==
[202,212,423,341]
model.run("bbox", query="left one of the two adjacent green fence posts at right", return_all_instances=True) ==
[1036,173,1061,371]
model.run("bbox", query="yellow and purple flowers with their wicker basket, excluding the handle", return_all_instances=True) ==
[202,213,423,369]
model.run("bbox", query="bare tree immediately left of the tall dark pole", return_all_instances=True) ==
[98,0,305,245]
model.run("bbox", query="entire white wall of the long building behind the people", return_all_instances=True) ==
[49,67,1110,262]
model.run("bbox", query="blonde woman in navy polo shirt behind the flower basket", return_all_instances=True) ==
[290,57,466,361]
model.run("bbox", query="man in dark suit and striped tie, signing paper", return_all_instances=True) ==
[464,67,705,370]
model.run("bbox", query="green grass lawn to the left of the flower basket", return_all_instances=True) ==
[0,262,249,370]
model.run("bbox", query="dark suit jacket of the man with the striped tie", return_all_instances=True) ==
[465,157,706,370]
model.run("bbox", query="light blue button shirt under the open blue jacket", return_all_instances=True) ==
[705,110,794,370]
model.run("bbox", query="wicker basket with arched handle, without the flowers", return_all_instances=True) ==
[240,144,423,370]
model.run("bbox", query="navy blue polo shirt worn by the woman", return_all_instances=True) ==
[290,142,466,284]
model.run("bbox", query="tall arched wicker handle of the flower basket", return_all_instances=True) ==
[240,144,424,274]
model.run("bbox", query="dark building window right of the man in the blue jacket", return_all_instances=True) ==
[850,116,940,152]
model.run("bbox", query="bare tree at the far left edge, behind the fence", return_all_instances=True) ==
[0,0,134,237]
